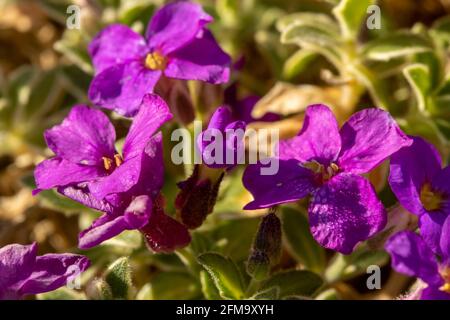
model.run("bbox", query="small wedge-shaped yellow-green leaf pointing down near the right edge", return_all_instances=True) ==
[403,63,431,112]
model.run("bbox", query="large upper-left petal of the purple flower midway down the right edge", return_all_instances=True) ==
[389,137,441,215]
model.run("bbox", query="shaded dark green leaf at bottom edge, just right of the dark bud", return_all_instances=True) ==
[260,270,323,298]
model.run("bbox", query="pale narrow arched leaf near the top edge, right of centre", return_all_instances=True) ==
[276,12,338,35]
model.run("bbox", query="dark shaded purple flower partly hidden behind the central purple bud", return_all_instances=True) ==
[224,83,281,124]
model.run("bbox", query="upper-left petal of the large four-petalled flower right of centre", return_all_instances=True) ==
[279,104,341,165]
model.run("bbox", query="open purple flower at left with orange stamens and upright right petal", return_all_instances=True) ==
[34,94,172,201]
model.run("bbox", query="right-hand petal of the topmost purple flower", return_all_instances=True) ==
[164,31,231,84]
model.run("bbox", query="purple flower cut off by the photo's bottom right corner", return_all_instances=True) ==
[385,217,450,300]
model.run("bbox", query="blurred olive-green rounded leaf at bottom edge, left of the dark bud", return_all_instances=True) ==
[143,272,200,300]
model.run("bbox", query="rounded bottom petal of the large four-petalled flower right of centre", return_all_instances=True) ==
[308,173,386,254]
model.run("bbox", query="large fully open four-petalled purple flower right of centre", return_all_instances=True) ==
[243,105,412,254]
